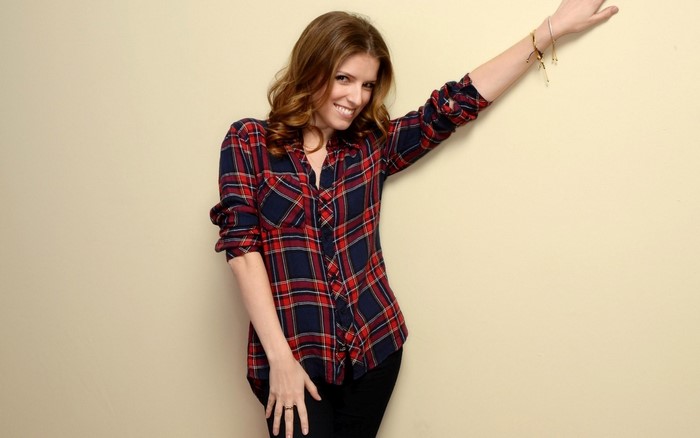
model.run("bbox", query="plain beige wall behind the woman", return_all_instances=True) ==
[0,0,700,438]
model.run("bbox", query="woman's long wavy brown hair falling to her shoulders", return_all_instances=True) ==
[267,11,393,156]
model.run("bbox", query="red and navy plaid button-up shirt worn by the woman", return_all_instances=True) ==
[211,76,488,383]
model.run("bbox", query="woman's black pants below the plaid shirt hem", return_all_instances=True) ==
[253,350,402,438]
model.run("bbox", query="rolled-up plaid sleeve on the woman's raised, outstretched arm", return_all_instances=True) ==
[383,74,490,174]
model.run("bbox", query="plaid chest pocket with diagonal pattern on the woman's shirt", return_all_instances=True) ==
[258,174,304,230]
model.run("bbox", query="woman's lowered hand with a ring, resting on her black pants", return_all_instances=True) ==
[265,351,321,438]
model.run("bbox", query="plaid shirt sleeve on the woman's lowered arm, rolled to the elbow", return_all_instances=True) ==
[209,123,262,259]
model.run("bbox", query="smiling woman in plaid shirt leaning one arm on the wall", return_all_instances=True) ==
[211,0,618,437]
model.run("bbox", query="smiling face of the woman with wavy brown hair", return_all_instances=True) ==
[312,53,379,139]
